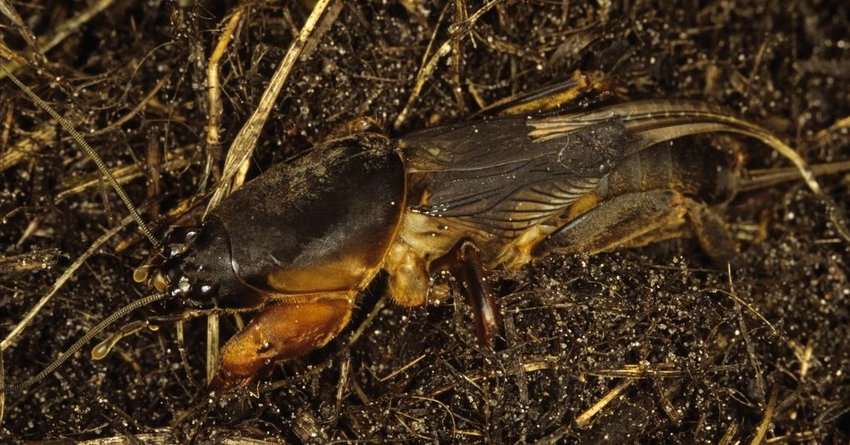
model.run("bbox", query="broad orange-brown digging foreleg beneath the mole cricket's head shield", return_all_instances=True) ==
[215,298,353,389]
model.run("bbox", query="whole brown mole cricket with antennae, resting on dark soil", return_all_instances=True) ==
[3,68,850,389]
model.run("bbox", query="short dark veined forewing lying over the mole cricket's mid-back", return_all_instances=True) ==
[401,114,631,232]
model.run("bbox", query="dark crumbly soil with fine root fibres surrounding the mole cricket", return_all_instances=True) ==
[0,0,850,443]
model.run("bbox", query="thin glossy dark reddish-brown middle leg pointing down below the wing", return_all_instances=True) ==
[449,241,500,349]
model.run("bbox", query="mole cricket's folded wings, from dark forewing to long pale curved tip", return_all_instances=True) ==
[402,100,822,236]
